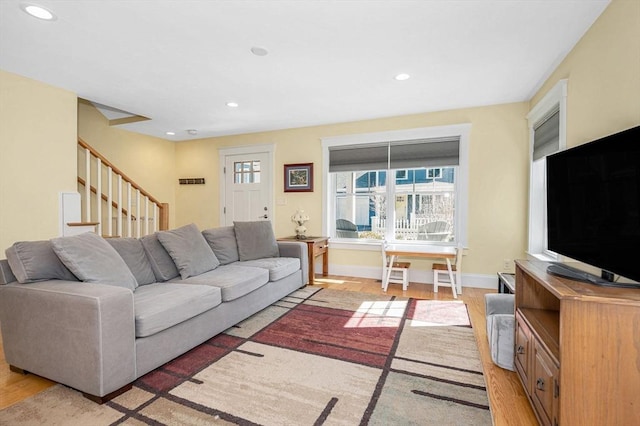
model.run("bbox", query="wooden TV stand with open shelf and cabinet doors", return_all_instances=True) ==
[515,260,640,426]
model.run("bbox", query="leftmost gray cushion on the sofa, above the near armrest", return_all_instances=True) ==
[5,241,78,284]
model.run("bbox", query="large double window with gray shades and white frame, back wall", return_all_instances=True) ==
[323,125,470,244]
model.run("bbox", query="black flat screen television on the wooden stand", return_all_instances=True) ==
[546,126,640,289]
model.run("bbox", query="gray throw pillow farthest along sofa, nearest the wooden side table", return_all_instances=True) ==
[233,220,280,261]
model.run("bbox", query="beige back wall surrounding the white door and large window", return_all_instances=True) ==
[176,102,528,274]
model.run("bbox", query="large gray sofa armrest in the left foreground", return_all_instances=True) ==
[0,280,136,396]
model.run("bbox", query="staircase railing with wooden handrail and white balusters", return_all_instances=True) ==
[74,138,169,238]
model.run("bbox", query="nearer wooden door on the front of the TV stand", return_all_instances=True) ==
[531,341,559,425]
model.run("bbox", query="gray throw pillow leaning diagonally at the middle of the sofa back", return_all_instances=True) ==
[157,223,220,279]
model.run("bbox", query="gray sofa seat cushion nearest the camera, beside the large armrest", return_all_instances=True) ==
[133,283,222,337]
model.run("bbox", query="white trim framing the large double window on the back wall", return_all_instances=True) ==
[321,123,471,249]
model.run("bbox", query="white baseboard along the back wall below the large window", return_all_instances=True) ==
[315,264,498,290]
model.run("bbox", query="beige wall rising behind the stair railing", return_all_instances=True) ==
[74,102,177,227]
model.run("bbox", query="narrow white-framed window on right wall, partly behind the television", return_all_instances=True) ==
[527,80,567,259]
